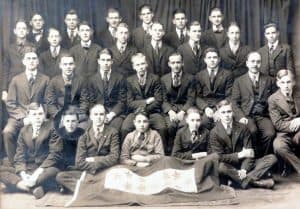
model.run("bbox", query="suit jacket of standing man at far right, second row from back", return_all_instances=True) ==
[258,44,295,77]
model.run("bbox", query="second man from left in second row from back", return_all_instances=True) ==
[39,28,66,79]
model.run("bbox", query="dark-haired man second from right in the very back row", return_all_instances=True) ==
[164,9,189,50]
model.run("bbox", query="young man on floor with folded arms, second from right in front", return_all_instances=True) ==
[172,107,210,160]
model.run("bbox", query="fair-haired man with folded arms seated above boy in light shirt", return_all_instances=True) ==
[121,53,167,149]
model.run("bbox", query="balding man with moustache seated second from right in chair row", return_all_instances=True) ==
[231,52,276,156]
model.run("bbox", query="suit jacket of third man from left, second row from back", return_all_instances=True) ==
[70,43,101,77]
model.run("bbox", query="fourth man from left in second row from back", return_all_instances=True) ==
[111,23,137,78]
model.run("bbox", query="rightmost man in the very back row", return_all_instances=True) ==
[201,8,226,49]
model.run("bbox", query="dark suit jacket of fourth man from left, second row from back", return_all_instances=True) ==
[111,44,137,78]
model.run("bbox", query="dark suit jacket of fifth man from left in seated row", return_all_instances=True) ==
[161,72,196,113]
